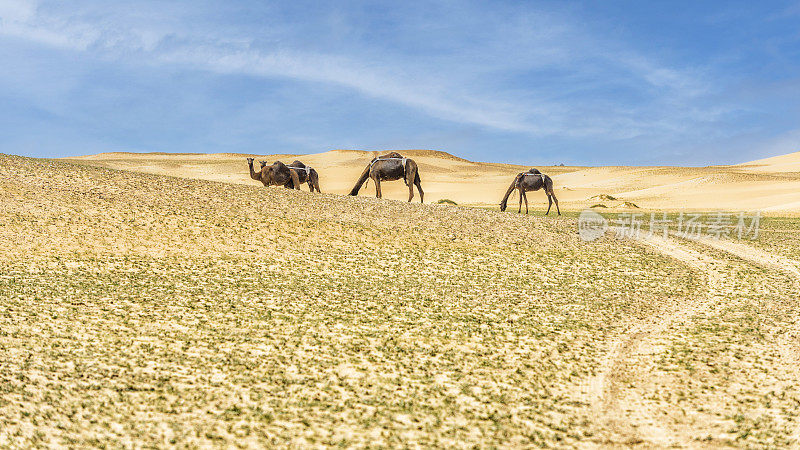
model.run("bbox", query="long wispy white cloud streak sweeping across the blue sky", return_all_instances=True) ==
[0,0,720,139]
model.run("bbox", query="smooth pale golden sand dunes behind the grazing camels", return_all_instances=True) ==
[67,150,800,214]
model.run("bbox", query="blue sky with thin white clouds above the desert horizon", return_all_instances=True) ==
[0,0,800,165]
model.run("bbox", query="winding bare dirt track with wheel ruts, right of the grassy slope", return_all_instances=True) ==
[590,232,800,447]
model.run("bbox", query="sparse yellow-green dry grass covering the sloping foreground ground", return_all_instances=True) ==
[0,156,797,447]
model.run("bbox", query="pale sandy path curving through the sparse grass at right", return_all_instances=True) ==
[590,237,800,447]
